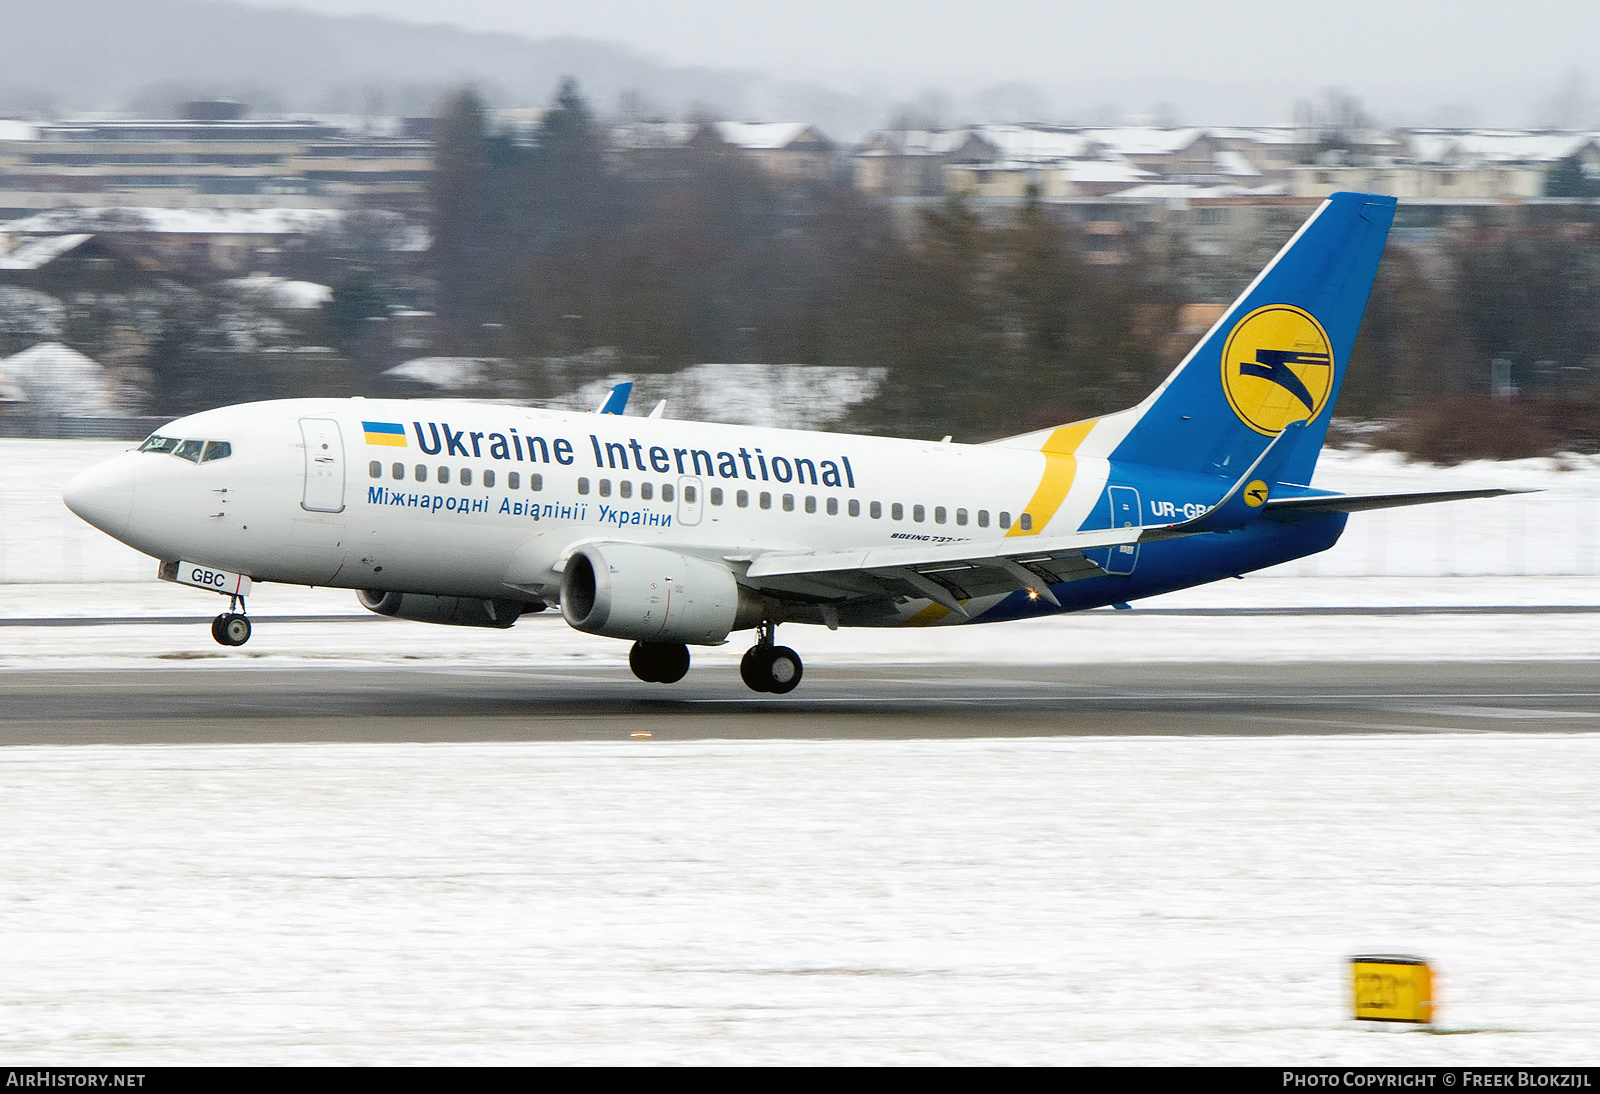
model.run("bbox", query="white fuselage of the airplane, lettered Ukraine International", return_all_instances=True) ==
[72,400,1139,622]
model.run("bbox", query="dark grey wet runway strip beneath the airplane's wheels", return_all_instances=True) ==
[0,661,1600,745]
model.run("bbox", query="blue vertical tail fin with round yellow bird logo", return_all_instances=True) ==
[1112,194,1395,483]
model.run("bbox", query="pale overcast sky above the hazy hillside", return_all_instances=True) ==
[232,0,1600,123]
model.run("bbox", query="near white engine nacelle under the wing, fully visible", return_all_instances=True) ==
[562,544,762,646]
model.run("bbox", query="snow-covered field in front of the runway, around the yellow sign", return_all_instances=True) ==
[0,734,1600,1065]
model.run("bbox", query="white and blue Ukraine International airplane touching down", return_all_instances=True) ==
[64,194,1517,694]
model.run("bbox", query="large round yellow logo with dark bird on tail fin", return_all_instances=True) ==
[1222,304,1333,437]
